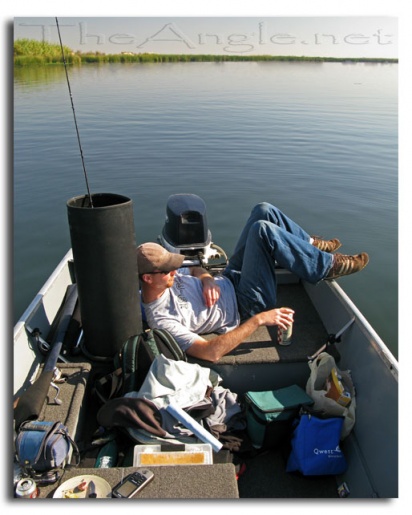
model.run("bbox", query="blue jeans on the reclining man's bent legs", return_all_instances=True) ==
[224,202,333,320]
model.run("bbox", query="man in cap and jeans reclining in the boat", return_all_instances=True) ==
[137,203,369,362]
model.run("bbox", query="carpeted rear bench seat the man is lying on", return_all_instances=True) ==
[189,283,328,393]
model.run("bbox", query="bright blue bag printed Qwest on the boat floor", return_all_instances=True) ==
[286,413,347,476]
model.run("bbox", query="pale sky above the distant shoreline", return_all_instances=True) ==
[14,15,398,58]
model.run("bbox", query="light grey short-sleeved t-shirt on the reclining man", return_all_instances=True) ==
[143,268,240,351]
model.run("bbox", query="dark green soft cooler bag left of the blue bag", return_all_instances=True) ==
[245,385,313,449]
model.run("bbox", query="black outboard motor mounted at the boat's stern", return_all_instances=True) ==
[158,193,228,270]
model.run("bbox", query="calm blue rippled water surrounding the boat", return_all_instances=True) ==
[13,63,398,356]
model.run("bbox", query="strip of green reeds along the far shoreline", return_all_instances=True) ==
[14,39,398,66]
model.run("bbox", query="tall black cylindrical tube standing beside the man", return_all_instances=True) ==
[67,193,142,358]
